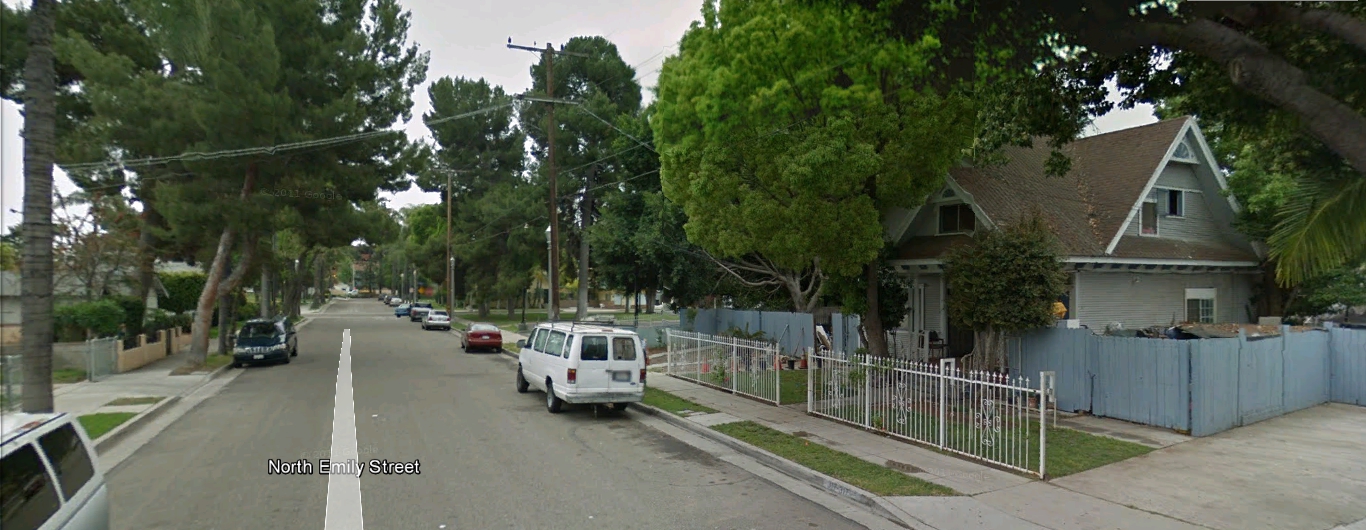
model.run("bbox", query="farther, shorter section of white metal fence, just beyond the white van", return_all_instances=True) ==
[664,329,800,404]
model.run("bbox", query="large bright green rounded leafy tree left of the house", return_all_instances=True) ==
[652,0,974,354]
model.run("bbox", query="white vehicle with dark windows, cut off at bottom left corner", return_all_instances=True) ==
[0,414,109,530]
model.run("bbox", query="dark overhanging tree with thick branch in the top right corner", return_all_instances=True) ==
[852,0,1366,283]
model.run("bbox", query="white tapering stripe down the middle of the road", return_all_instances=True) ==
[320,329,365,530]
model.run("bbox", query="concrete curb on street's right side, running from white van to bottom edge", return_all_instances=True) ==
[631,403,923,529]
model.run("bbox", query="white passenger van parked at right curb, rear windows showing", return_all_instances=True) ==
[516,322,645,413]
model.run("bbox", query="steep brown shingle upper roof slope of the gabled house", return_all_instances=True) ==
[949,117,1187,255]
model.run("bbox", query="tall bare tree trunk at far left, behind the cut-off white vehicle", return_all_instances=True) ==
[19,0,57,413]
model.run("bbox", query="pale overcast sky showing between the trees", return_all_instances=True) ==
[0,0,1157,232]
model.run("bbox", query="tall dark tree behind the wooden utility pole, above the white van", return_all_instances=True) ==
[519,37,641,317]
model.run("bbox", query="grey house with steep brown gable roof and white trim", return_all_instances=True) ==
[885,117,1262,355]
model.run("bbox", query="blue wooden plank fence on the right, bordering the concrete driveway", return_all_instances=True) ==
[1011,328,1366,436]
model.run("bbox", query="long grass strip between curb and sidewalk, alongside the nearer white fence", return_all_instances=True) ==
[712,421,958,496]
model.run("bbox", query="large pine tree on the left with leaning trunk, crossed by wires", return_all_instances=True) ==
[67,0,426,362]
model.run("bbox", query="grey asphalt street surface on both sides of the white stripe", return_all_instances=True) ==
[108,299,861,530]
